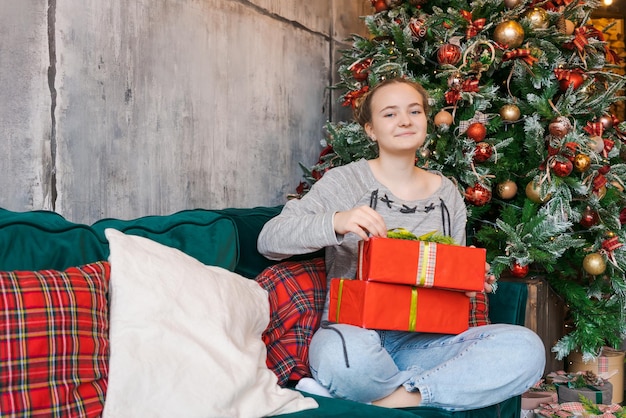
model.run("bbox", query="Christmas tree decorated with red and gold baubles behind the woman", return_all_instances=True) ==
[299,0,626,359]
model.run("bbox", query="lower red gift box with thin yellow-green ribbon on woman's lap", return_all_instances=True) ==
[328,279,470,334]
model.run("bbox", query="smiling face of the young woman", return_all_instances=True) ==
[365,83,428,154]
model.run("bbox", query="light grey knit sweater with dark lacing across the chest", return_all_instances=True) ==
[258,160,467,318]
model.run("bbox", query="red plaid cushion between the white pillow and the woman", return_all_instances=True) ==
[256,258,326,385]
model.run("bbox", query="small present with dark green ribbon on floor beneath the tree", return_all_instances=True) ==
[547,371,613,405]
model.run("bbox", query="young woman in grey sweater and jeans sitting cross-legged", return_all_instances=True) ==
[258,78,545,410]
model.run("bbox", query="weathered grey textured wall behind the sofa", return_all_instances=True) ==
[0,0,371,223]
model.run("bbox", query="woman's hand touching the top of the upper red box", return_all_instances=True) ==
[334,206,387,241]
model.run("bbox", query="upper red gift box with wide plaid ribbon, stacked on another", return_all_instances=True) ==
[356,237,487,292]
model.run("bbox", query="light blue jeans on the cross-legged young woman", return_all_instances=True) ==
[309,323,546,410]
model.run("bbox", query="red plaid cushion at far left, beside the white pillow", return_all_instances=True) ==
[0,262,110,417]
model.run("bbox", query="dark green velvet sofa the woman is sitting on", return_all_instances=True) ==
[0,206,527,418]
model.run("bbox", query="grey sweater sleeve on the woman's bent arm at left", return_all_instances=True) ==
[257,162,364,260]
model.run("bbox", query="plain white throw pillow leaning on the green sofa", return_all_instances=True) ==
[103,229,317,418]
